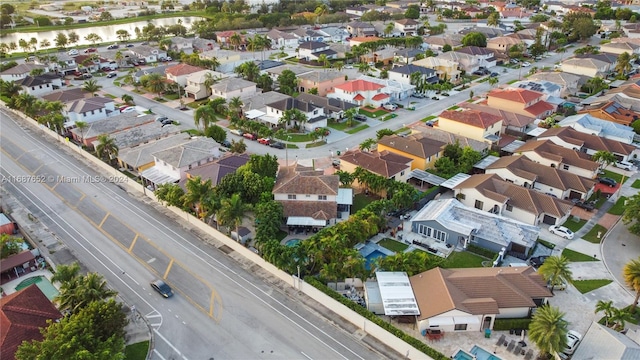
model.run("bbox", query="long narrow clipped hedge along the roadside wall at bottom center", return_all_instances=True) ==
[304,277,449,360]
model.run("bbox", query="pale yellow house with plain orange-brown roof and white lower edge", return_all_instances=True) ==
[437,110,503,143]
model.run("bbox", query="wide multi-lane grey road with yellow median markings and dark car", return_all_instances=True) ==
[0,109,398,359]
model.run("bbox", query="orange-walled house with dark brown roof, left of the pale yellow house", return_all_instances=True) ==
[377,135,446,170]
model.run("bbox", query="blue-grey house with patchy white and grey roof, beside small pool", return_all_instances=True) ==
[410,199,540,257]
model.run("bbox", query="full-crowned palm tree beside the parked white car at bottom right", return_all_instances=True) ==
[529,304,568,356]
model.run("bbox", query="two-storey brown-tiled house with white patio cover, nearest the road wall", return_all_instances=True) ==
[273,165,353,228]
